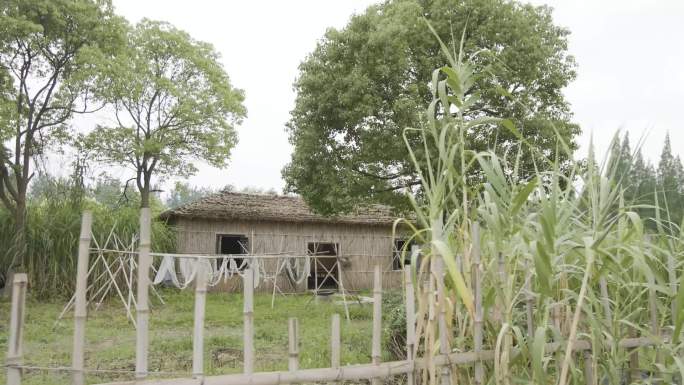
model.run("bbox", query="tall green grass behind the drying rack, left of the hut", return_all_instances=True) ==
[0,176,175,299]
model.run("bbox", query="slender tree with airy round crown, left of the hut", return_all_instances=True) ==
[85,20,246,207]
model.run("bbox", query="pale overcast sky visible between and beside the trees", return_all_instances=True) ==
[103,0,684,191]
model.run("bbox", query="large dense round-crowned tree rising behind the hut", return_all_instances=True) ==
[283,0,580,213]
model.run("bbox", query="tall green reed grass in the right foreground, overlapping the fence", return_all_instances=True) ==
[402,25,684,385]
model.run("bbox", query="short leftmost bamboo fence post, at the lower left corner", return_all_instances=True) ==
[5,273,28,385]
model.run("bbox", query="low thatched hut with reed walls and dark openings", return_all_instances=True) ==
[161,192,406,292]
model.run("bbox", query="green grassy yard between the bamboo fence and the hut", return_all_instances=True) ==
[0,290,384,385]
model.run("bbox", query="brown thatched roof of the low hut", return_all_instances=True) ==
[161,192,396,225]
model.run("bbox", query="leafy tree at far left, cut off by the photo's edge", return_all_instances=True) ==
[0,0,123,268]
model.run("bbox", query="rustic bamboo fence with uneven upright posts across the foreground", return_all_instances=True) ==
[5,209,668,385]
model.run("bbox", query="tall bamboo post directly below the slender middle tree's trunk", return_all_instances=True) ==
[135,207,152,379]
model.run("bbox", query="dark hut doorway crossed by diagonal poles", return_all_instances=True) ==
[307,242,340,291]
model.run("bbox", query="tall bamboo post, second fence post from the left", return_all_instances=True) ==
[71,211,93,385]
